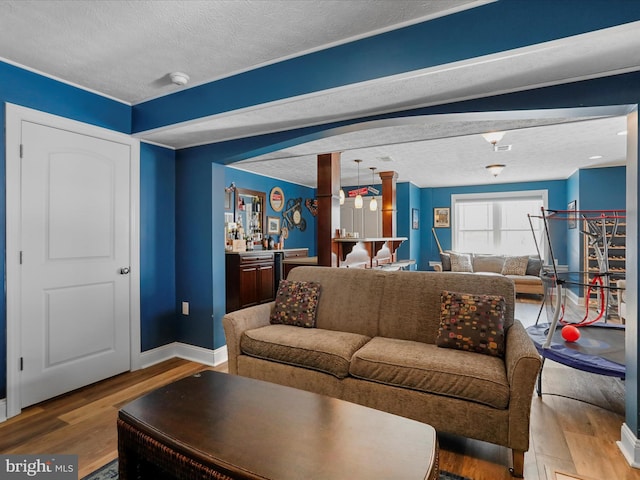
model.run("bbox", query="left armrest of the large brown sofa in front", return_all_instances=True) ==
[222,302,275,375]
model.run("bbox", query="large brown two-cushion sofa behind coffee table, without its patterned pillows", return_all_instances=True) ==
[223,267,541,476]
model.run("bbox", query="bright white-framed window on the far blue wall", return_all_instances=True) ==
[451,190,547,258]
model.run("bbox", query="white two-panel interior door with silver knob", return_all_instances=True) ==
[20,121,131,407]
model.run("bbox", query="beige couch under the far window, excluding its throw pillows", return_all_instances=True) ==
[434,251,544,295]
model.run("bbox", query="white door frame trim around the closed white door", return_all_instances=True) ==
[5,103,141,418]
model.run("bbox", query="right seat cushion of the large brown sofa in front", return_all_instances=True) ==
[349,337,509,409]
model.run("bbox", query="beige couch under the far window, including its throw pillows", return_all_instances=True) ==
[434,251,544,295]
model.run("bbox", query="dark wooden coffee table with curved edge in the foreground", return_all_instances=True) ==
[118,371,438,480]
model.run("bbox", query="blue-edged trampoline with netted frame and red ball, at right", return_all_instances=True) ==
[527,208,626,395]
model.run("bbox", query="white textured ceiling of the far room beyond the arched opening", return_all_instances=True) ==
[233,115,626,187]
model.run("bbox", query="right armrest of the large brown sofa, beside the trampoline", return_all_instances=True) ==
[505,320,542,451]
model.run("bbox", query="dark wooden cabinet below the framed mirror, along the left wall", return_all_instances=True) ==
[225,251,275,312]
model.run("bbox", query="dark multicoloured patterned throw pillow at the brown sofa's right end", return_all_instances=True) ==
[436,291,506,357]
